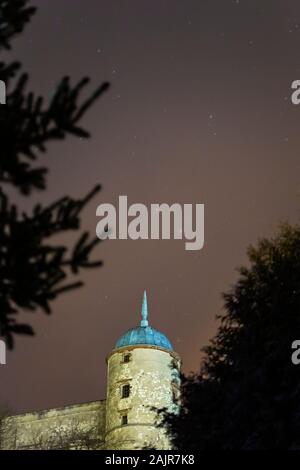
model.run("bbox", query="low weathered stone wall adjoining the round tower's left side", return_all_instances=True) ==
[0,400,105,450]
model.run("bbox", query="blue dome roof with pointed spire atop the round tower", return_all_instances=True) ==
[115,292,173,351]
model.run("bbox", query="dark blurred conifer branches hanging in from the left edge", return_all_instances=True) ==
[0,0,109,348]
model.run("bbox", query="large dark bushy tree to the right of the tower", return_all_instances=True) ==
[167,224,300,451]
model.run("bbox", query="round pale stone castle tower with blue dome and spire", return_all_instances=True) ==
[105,292,180,450]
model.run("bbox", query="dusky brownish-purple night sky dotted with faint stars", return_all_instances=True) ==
[0,0,300,412]
